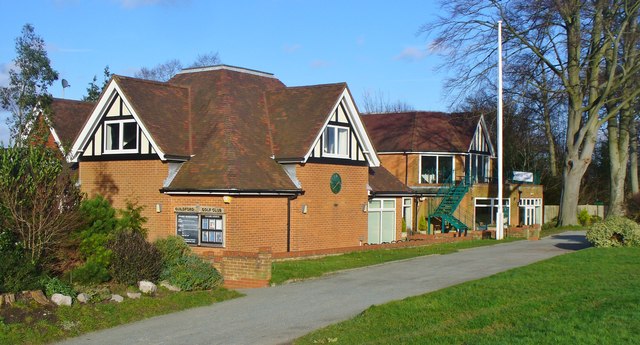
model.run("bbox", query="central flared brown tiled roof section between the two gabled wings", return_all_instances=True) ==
[166,69,298,190]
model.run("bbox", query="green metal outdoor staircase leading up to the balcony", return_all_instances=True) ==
[428,178,473,233]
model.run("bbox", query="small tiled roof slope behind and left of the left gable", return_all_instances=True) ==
[49,98,96,148]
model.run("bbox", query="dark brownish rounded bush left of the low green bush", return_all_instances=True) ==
[109,232,163,285]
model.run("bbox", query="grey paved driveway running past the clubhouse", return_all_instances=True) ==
[57,231,588,345]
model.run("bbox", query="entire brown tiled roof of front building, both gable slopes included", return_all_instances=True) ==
[55,66,402,192]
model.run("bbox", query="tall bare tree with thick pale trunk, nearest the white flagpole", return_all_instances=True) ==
[423,0,640,225]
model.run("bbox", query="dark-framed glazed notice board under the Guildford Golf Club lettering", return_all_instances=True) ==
[176,213,225,247]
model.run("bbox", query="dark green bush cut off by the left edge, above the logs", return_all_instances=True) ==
[0,231,42,292]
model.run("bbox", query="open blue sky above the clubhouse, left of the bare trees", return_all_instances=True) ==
[0,0,447,143]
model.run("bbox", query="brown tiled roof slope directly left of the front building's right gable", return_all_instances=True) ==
[266,83,347,159]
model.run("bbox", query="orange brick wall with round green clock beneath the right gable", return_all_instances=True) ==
[288,163,369,252]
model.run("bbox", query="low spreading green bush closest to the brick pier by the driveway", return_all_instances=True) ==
[162,254,222,291]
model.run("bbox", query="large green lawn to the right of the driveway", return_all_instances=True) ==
[295,248,640,344]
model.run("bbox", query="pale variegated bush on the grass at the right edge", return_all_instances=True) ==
[587,217,640,247]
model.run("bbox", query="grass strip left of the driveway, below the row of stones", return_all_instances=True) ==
[0,288,242,344]
